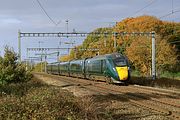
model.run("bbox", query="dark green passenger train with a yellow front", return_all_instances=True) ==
[47,53,131,84]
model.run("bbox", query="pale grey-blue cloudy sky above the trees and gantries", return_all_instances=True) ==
[0,0,180,62]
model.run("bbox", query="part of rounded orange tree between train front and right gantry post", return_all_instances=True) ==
[126,37,151,75]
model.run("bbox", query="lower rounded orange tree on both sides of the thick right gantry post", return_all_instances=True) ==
[126,37,177,76]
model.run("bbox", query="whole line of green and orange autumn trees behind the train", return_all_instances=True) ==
[60,15,180,76]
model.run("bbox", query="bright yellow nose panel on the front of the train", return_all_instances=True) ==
[116,67,128,80]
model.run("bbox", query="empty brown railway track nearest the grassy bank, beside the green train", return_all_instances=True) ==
[34,74,180,120]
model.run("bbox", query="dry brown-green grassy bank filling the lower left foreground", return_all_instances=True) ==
[0,78,109,120]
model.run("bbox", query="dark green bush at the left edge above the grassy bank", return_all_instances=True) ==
[0,46,32,84]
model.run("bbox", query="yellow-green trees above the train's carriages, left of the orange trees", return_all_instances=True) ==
[61,28,114,61]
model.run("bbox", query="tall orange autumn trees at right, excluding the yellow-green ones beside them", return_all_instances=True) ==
[114,15,180,75]
